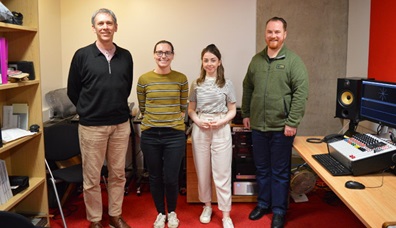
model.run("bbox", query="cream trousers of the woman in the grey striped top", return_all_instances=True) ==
[191,114,232,212]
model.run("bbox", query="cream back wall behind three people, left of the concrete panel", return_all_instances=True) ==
[60,0,256,108]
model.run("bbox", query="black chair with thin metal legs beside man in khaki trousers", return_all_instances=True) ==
[44,122,83,227]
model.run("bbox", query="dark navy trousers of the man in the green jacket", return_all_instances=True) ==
[252,130,294,215]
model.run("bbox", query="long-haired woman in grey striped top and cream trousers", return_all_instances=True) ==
[188,44,236,228]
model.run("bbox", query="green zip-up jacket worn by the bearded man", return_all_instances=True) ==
[241,45,308,132]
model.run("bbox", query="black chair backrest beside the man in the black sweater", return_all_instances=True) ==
[44,121,81,161]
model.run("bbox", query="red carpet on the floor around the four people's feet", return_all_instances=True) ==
[51,183,364,228]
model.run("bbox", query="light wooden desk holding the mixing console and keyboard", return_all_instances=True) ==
[293,136,396,228]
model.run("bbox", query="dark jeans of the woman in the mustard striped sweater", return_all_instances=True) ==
[140,128,186,214]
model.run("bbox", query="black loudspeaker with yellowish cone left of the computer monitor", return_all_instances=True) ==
[335,78,362,122]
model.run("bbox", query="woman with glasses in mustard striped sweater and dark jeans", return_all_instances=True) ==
[136,40,188,228]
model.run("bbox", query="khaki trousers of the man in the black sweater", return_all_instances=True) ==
[78,121,131,222]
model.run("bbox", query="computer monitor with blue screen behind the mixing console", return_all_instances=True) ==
[360,80,396,128]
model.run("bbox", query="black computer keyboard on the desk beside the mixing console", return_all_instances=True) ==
[312,154,352,176]
